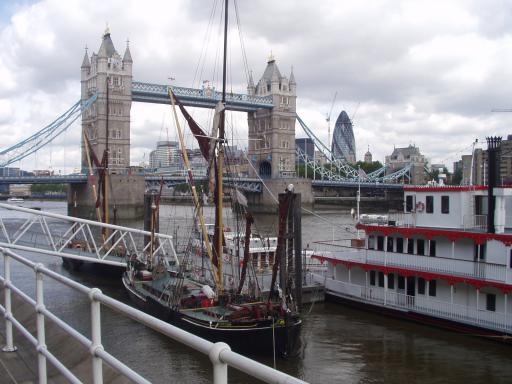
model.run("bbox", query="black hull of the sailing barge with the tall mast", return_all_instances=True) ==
[123,279,302,357]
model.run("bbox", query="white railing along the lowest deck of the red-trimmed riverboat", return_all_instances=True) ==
[315,275,512,333]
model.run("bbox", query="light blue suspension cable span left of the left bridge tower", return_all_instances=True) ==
[0,93,98,167]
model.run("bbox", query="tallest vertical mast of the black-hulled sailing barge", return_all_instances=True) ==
[215,0,228,294]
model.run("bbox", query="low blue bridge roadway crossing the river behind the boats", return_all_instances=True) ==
[0,173,403,193]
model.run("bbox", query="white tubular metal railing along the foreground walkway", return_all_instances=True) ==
[0,248,304,384]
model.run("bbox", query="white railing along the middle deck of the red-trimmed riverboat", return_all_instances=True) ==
[315,245,512,284]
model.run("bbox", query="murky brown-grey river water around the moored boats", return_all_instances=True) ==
[0,202,512,384]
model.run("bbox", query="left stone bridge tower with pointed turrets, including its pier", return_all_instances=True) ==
[68,28,145,222]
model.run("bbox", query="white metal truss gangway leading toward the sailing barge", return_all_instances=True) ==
[0,203,179,267]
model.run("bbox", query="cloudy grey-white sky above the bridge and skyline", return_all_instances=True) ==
[0,0,512,172]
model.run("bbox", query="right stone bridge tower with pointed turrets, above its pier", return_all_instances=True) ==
[247,55,297,179]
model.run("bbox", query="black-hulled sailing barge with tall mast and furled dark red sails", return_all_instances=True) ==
[123,1,302,356]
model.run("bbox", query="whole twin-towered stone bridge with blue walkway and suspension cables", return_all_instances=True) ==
[0,30,408,218]
